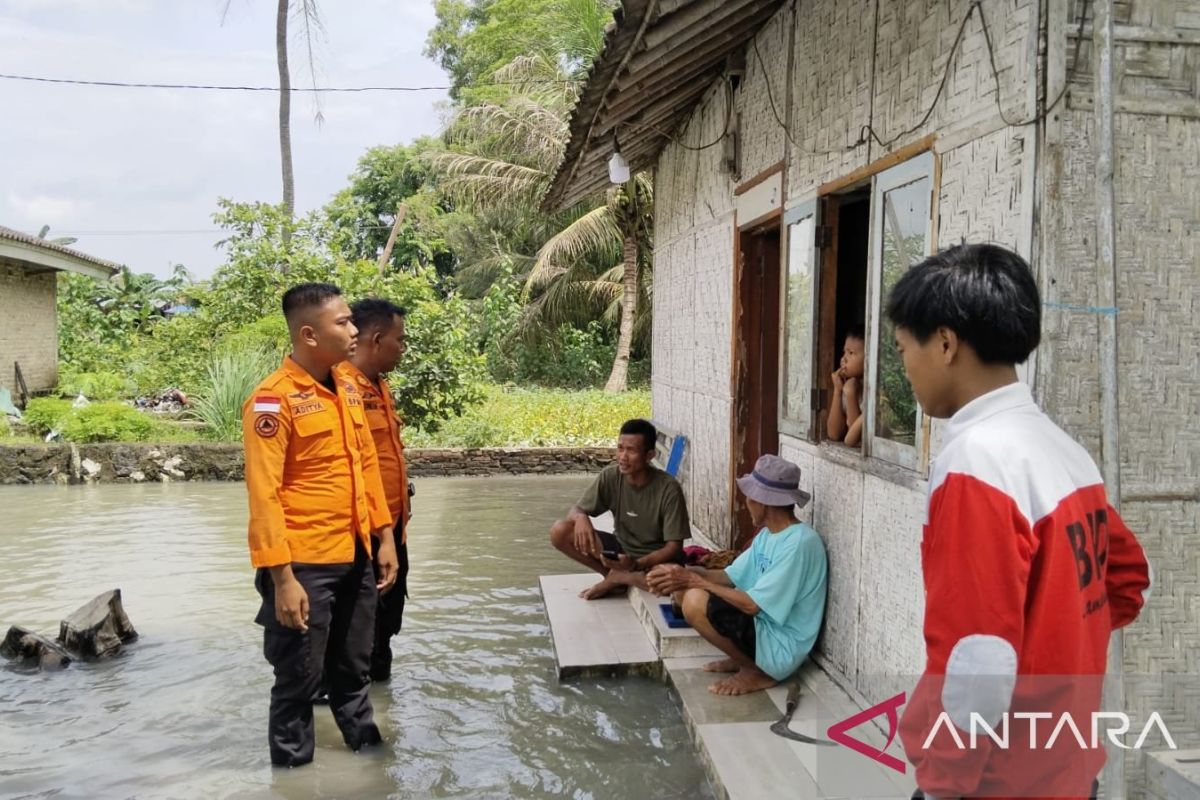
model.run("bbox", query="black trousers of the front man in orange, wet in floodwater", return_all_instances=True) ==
[254,542,380,766]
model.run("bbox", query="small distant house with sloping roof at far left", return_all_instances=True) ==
[0,227,120,399]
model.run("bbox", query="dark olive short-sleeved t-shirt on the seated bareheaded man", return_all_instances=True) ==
[577,464,691,558]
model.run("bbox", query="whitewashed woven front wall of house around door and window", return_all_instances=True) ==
[652,0,1038,700]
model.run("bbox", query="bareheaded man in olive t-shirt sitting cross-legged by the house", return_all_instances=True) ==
[550,420,691,600]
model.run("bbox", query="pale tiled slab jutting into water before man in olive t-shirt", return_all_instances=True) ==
[539,572,659,679]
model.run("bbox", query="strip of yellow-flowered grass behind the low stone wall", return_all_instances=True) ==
[404,386,650,447]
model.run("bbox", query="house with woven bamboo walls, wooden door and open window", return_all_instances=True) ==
[546,0,1200,796]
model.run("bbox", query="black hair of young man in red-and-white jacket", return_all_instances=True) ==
[887,245,1042,363]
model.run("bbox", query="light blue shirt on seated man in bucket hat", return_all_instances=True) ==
[725,523,828,680]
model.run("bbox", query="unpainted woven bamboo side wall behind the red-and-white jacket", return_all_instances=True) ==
[1037,0,1200,796]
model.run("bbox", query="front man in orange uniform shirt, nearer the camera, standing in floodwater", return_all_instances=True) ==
[242,283,396,766]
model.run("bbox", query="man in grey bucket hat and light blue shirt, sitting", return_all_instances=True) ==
[647,456,828,694]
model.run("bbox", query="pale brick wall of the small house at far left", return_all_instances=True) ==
[0,259,59,398]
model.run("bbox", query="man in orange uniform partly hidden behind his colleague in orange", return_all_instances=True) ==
[342,299,410,682]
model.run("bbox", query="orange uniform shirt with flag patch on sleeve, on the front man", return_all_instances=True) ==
[241,356,392,567]
